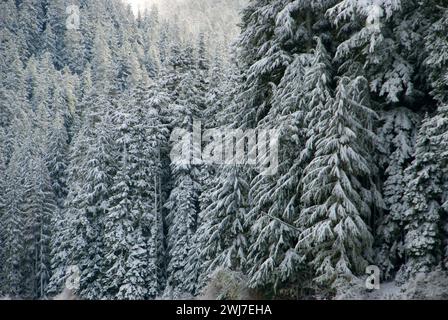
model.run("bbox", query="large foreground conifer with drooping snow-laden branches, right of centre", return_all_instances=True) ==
[298,78,377,285]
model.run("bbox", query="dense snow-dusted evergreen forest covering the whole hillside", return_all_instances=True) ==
[0,0,448,299]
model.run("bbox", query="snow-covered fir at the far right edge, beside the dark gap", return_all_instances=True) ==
[400,108,446,279]
